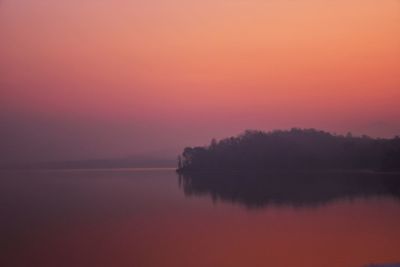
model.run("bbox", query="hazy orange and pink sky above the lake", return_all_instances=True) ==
[0,0,400,162]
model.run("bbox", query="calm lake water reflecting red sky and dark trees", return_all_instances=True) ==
[0,170,400,267]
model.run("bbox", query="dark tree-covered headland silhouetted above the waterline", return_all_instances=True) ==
[177,128,400,172]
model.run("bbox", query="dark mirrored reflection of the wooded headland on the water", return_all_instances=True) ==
[178,171,400,208]
